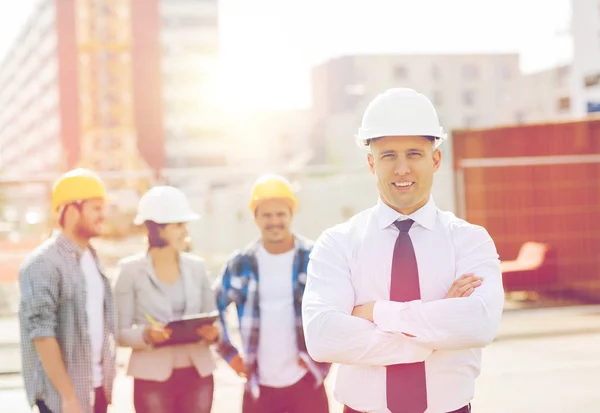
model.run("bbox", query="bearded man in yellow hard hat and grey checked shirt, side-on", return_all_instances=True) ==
[19,169,116,413]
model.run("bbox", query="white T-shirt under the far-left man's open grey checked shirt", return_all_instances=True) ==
[81,249,104,388]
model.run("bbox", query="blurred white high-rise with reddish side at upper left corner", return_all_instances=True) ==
[0,1,63,174]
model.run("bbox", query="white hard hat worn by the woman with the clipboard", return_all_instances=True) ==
[133,186,200,225]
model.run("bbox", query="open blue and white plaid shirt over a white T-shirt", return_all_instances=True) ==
[215,236,330,396]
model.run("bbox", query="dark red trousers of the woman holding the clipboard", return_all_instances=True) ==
[133,367,215,413]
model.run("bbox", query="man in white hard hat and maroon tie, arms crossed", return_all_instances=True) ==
[302,88,504,413]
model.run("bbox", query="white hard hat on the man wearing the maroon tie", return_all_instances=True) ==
[356,88,447,148]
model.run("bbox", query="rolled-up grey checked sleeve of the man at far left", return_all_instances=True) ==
[19,258,60,340]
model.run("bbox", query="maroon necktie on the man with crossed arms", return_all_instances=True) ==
[386,219,427,413]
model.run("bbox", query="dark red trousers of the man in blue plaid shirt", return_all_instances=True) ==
[242,373,329,413]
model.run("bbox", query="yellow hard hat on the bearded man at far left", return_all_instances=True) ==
[52,168,106,215]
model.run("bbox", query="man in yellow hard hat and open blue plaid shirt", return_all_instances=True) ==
[216,175,329,413]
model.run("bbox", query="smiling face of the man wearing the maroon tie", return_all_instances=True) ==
[368,136,442,215]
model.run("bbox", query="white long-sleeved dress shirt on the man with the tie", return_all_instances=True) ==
[302,199,504,413]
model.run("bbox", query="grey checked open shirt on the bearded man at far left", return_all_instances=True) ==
[19,233,116,413]
